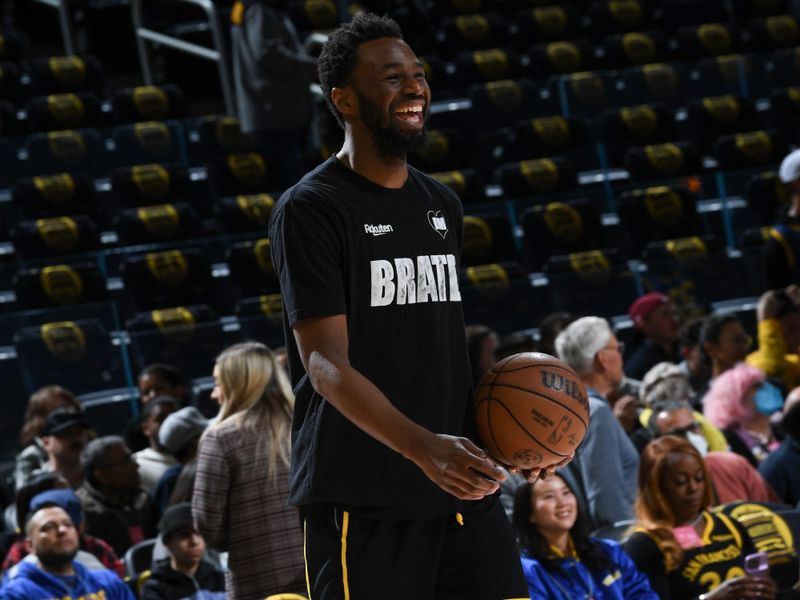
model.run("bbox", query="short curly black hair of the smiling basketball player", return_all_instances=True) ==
[317,13,403,128]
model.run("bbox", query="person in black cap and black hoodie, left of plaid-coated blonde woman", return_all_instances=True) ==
[140,502,225,600]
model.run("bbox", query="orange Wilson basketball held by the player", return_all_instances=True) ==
[475,352,589,469]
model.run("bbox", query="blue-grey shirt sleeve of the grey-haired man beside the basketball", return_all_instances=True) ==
[578,403,636,526]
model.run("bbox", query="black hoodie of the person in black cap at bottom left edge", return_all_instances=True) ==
[141,558,225,600]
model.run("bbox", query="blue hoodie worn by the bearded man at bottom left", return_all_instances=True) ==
[0,561,135,600]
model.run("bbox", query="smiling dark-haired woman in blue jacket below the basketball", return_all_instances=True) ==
[513,475,658,600]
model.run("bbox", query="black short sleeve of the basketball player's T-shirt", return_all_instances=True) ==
[270,192,347,326]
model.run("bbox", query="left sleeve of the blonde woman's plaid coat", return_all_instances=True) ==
[192,429,230,552]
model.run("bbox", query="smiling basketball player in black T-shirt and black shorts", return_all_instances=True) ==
[270,15,544,600]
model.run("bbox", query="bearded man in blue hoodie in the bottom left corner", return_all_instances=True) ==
[0,506,134,600]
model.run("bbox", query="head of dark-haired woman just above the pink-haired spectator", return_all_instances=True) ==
[698,315,753,396]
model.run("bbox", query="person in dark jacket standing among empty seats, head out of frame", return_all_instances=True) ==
[231,0,317,187]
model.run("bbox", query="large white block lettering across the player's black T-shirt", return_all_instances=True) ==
[369,254,461,306]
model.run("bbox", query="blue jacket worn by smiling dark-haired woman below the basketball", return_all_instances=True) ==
[522,538,658,600]
